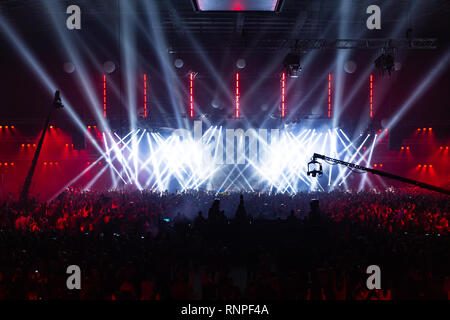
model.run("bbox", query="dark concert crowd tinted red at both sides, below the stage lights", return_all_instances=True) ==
[0,189,450,300]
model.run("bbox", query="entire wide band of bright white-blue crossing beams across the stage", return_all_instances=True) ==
[79,126,375,194]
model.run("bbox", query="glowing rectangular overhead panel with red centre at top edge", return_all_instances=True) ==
[192,0,284,12]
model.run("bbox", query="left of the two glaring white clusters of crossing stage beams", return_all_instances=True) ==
[99,129,214,191]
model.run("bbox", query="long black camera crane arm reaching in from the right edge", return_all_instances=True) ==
[311,153,450,195]
